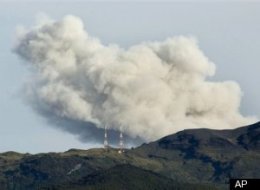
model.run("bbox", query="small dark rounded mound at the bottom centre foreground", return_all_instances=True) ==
[59,164,219,190]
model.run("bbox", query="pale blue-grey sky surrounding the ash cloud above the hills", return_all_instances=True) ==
[0,0,260,153]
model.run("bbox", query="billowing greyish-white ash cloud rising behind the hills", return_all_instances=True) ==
[14,16,253,144]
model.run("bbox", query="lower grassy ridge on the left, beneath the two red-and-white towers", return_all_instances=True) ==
[0,149,219,190]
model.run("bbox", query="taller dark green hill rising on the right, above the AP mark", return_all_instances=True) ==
[133,123,260,183]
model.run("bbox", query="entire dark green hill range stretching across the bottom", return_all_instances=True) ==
[0,123,260,190]
